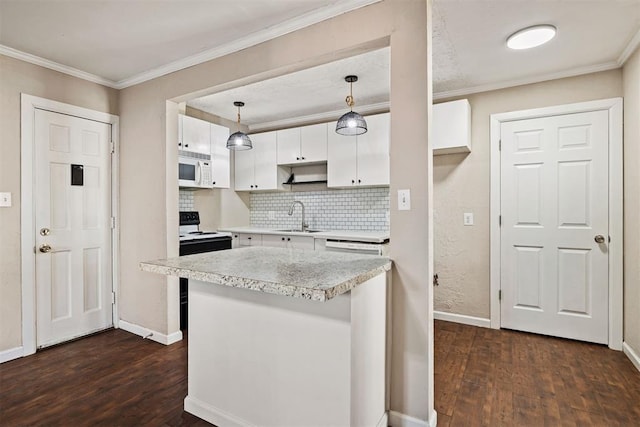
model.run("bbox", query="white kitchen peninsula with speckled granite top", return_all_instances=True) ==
[140,247,391,427]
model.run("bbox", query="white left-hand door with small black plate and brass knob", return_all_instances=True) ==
[34,110,113,347]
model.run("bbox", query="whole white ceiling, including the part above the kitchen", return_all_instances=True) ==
[0,0,640,129]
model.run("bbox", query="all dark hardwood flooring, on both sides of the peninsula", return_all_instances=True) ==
[0,321,640,427]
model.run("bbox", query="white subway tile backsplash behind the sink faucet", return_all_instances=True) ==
[250,187,389,231]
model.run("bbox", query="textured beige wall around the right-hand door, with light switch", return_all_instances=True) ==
[433,69,624,319]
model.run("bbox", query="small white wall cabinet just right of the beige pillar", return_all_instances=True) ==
[431,99,471,155]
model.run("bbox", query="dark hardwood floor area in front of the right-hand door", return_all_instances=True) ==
[434,321,640,426]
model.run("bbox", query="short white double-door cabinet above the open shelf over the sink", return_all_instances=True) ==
[276,123,327,166]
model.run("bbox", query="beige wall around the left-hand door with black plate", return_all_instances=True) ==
[0,55,118,351]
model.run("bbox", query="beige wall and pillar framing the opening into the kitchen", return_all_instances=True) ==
[120,0,433,420]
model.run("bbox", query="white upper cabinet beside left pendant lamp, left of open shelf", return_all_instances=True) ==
[235,132,289,191]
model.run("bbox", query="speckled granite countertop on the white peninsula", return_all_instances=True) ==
[140,246,391,301]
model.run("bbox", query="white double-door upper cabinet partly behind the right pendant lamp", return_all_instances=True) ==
[327,113,390,187]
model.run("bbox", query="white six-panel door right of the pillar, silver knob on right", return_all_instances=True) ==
[500,111,609,344]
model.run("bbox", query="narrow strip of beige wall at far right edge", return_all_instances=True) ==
[622,48,640,355]
